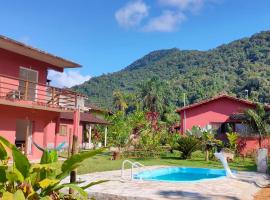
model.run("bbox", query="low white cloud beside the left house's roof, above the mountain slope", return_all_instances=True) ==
[48,70,91,88]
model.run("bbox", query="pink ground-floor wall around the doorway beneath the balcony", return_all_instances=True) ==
[0,105,59,159]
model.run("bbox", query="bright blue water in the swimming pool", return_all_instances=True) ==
[134,167,229,182]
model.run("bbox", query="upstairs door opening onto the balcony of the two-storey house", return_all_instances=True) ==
[19,67,38,101]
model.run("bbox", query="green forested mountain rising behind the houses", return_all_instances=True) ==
[73,31,270,108]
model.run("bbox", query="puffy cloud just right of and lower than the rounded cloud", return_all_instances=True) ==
[143,10,186,32]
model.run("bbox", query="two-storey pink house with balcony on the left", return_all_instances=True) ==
[0,36,96,159]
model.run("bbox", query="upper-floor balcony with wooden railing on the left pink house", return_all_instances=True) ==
[0,74,84,112]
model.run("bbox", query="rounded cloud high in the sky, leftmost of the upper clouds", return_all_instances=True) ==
[115,0,149,28]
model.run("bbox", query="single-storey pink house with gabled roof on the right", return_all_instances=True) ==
[176,94,270,154]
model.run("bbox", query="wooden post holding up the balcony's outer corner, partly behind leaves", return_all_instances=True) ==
[69,108,80,194]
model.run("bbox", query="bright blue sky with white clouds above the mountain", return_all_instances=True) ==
[0,0,270,87]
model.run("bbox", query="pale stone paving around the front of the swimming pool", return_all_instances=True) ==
[73,166,269,200]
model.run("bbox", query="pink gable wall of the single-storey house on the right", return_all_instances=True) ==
[180,97,253,133]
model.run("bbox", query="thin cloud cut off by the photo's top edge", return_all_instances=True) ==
[159,0,207,12]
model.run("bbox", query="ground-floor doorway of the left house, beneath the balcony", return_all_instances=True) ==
[15,119,33,155]
